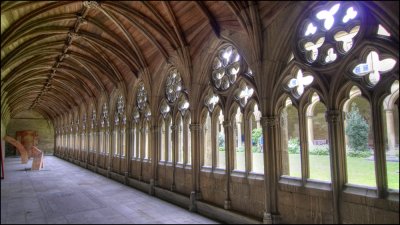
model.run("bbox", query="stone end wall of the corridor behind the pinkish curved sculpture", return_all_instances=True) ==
[6,111,54,155]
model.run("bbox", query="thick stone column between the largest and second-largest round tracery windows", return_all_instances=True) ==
[261,116,280,224]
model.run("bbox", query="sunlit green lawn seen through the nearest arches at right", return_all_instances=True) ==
[289,154,399,190]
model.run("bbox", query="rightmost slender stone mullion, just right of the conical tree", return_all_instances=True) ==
[371,104,390,198]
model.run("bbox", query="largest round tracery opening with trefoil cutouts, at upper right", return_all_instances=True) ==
[297,2,362,66]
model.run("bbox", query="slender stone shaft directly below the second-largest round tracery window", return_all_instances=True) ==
[223,120,234,209]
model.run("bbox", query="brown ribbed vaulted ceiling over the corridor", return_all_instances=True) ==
[1,1,288,119]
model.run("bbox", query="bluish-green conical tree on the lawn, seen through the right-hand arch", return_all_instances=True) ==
[346,103,369,153]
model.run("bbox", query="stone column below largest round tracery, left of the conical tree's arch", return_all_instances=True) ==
[325,110,346,224]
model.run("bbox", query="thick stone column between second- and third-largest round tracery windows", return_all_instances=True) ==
[189,123,201,212]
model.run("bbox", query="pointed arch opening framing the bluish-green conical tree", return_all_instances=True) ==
[342,86,376,187]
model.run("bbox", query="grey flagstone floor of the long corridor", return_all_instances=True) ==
[1,156,217,224]
